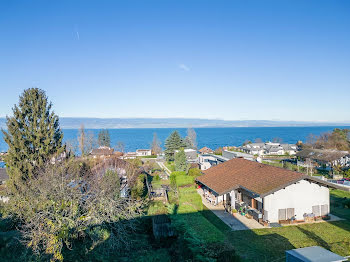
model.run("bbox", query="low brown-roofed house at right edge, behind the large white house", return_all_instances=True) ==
[296,149,350,168]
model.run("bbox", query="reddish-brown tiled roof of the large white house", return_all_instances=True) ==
[197,158,306,197]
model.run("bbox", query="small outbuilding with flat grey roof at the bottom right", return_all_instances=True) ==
[286,246,348,262]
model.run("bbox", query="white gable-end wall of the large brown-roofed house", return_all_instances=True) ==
[264,180,329,222]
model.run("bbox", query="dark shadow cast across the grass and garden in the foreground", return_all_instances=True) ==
[0,210,350,262]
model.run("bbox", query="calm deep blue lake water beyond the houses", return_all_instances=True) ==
[0,126,348,151]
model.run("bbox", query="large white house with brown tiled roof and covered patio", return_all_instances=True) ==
[196,158,340,223]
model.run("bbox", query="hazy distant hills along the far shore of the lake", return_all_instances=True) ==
[0,117,350,129]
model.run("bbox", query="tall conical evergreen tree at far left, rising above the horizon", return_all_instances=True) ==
[2,88,64,185]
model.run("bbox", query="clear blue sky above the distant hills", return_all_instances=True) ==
[0,0,350,121]
